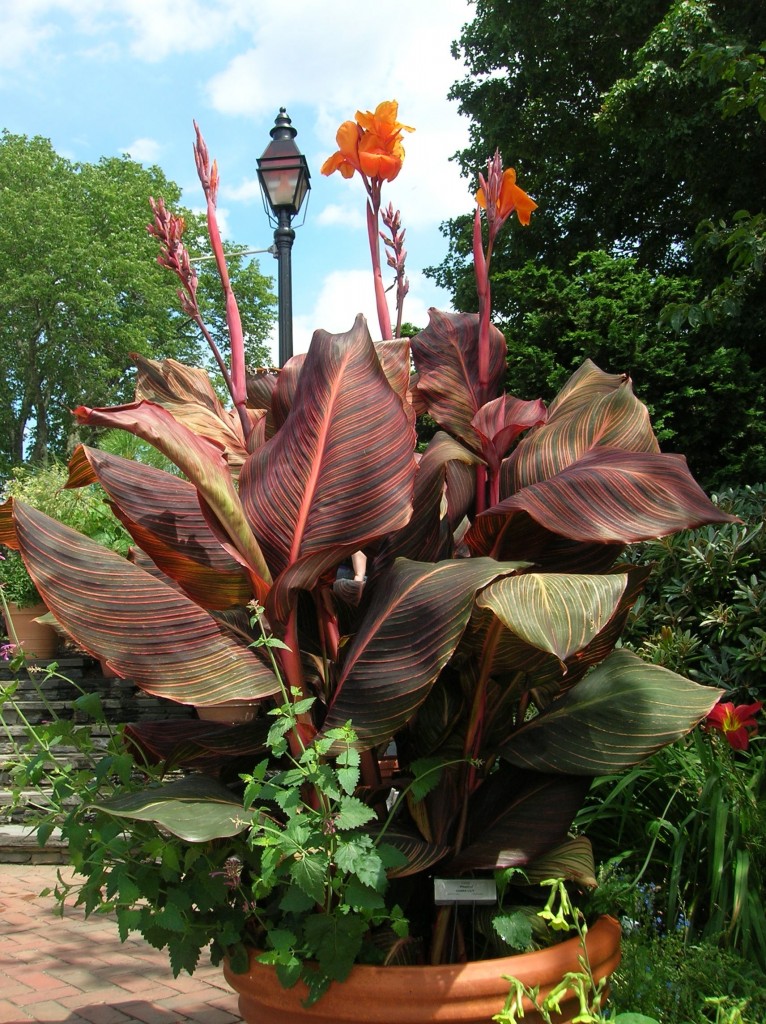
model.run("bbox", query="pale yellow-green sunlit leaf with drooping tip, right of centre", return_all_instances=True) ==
[476,572,628,670]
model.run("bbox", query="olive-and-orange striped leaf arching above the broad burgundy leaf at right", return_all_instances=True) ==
[501,364,659,497]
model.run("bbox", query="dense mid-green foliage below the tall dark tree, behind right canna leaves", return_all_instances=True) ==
[493,252,766,478]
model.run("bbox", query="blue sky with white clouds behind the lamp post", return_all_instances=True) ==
[0,0,475,362]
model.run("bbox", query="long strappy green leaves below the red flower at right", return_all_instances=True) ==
[579,731,766,970]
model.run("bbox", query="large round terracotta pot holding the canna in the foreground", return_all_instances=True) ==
[224,916,621,1024]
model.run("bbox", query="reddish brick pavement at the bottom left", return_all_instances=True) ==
[0,864,241,1024]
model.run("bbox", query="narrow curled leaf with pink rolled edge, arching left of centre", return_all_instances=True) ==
[75,401,271,601]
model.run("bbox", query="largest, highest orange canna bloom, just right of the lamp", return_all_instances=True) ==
[322,99,415,181]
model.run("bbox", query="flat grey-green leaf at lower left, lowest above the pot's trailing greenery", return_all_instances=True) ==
[88,775,250,843]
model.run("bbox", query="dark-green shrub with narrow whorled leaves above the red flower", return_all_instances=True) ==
[624,484,766,703]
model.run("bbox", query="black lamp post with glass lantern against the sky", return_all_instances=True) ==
[258,106,311,367]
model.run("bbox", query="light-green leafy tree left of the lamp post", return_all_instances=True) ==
[0,131,273,477]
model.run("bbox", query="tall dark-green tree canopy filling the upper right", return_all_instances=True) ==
[431,0,766,482]
